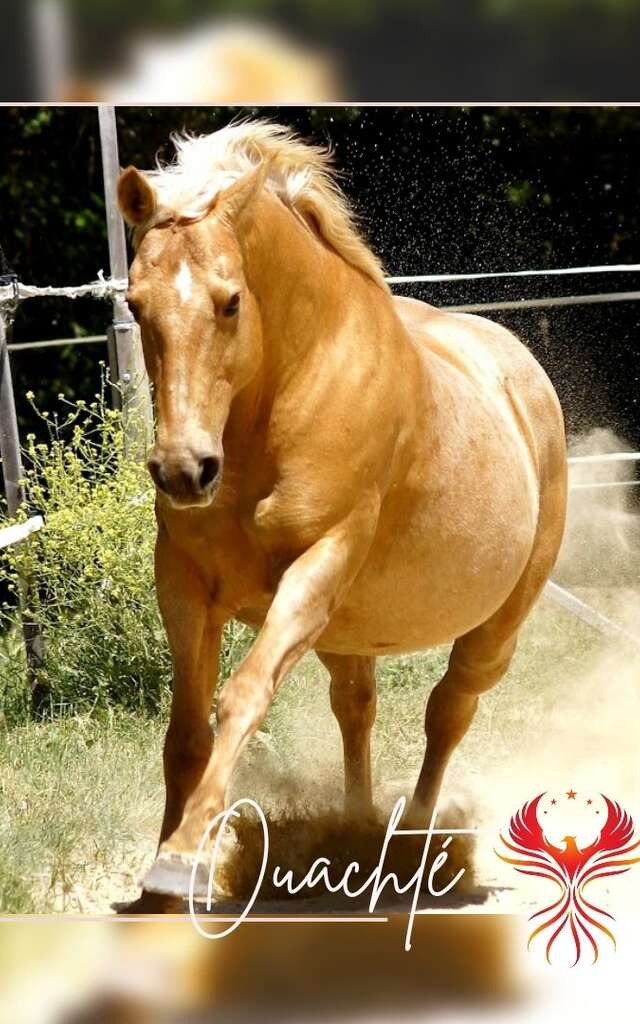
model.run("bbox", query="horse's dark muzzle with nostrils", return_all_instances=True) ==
[147,449,222,508]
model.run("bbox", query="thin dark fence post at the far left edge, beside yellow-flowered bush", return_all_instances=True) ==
[0,307,48,714]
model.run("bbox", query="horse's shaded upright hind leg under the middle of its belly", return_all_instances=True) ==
[316,651,376,816]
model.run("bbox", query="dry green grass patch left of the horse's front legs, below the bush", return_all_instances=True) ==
[0,712,164,913]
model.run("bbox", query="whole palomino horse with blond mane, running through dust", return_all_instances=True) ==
[119,122,566,908]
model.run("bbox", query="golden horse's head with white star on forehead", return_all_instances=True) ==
[118,166,265,508]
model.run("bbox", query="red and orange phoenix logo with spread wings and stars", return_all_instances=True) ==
[496,791,640,967]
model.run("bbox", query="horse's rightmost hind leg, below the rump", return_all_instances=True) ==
[411,478,564,822]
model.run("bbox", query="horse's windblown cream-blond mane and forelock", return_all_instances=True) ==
[135,120,388,291]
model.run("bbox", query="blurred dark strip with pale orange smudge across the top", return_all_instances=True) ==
[0,0,640,103]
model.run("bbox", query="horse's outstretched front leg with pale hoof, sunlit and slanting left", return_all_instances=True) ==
[144,496,379,896]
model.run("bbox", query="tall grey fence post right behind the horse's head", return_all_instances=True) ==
[98,105,154,457]
